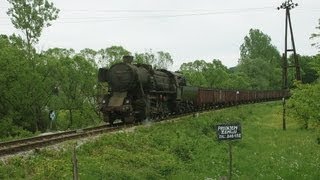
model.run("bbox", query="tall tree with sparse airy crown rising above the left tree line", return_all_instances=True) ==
[7,0,59,131]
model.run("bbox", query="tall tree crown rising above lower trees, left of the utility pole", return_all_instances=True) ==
[240,29,281,66]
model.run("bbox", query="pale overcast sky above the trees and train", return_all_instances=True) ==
[0,0,320,70]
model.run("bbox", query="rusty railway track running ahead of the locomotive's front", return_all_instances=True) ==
[0,124,134,157]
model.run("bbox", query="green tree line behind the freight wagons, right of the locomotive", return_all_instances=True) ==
[180,29,318,90]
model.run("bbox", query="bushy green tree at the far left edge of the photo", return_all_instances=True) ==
[0,35,27,129]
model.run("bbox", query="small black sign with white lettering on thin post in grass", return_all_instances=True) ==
[217,123,242,180]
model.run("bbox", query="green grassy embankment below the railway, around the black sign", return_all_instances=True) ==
[0,102,320,179]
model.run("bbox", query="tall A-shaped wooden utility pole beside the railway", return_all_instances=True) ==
[277,0,301,130]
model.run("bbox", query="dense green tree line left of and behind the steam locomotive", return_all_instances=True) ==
[0,35,172,136]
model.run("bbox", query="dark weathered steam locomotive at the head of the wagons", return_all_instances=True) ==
[98,56,186,124]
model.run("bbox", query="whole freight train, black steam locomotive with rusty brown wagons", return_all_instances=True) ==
[98,56,287,124]
